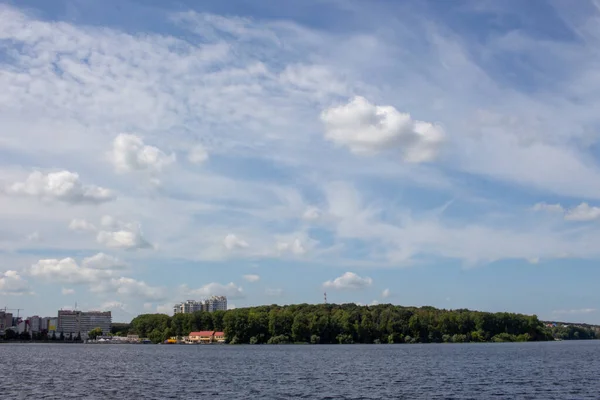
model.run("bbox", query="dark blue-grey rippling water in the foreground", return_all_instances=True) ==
[0,341,600,399]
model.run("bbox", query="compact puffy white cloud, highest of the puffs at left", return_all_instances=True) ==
[111,133,175,173]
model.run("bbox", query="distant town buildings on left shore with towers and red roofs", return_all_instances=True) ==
[0,296,227,343]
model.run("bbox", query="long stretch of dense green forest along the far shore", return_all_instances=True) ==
[113,304,596,344]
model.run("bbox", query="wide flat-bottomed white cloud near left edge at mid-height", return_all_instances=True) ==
[5,171,115,204]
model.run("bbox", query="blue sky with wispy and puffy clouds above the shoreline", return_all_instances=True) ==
[0,0,600,323]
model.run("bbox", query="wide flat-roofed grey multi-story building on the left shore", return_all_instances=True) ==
[57,310,112,339]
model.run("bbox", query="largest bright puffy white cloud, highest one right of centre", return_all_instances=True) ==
[321,96,445,163]
